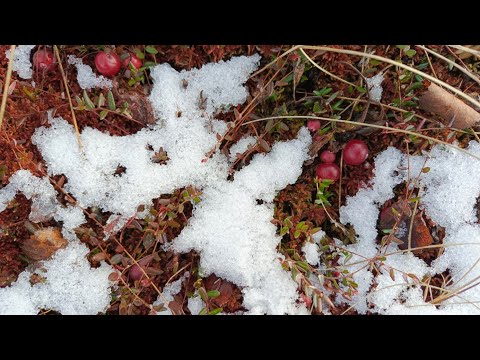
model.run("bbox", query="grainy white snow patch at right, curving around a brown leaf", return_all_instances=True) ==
[340,141,480,314]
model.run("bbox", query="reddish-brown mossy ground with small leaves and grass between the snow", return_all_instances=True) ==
[0,45,480,315]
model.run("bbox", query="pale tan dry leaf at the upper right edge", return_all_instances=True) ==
[419,83,480,129]
